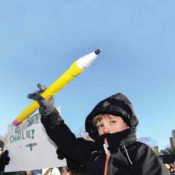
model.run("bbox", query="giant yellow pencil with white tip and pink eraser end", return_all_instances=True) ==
[13,49,100,126]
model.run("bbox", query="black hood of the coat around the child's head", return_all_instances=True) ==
[85,93,138,139]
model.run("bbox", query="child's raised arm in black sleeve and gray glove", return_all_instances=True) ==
[28,84,96,163]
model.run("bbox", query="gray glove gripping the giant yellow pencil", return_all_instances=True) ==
[27,84,55,115]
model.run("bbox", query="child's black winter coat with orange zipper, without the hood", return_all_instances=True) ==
[41,110,169,175]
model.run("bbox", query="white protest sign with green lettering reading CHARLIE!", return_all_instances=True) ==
[5,111,66,172]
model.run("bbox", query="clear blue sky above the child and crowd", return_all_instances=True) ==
[0,0,175,149]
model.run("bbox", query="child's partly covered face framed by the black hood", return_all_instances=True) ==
[96,114,129,135]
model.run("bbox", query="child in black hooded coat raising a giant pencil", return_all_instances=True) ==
[28,85,169,175]
